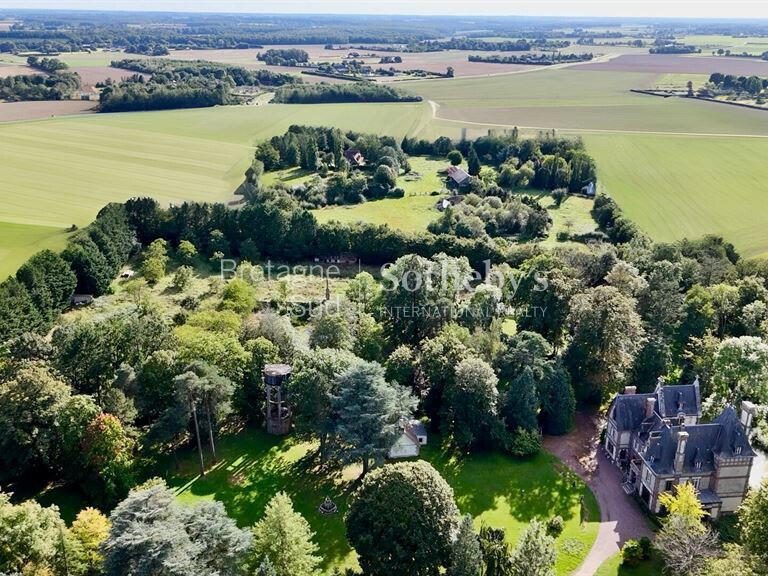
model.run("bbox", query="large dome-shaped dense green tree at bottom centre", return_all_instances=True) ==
[344,460,458,576]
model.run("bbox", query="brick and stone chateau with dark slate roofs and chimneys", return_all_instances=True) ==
[605,378,755,518]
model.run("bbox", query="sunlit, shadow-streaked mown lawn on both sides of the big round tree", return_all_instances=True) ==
[159,431,599,576]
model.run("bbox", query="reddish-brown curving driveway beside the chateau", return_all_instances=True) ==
[544,412,653,576]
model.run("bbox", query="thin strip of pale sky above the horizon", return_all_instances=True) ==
[0,0,768,18]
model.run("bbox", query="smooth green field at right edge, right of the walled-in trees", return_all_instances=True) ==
[585,133,768,257]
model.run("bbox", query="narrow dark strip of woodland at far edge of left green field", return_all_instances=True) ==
[272,82,421,104]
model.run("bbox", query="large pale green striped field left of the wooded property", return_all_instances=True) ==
[0,103,429,279]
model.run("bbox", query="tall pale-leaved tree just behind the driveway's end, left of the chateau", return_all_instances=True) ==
[565,286,645,400]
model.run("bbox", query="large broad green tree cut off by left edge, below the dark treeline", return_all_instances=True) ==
[0,361,70,481]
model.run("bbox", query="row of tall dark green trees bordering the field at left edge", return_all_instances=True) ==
[0,204,136,342]
